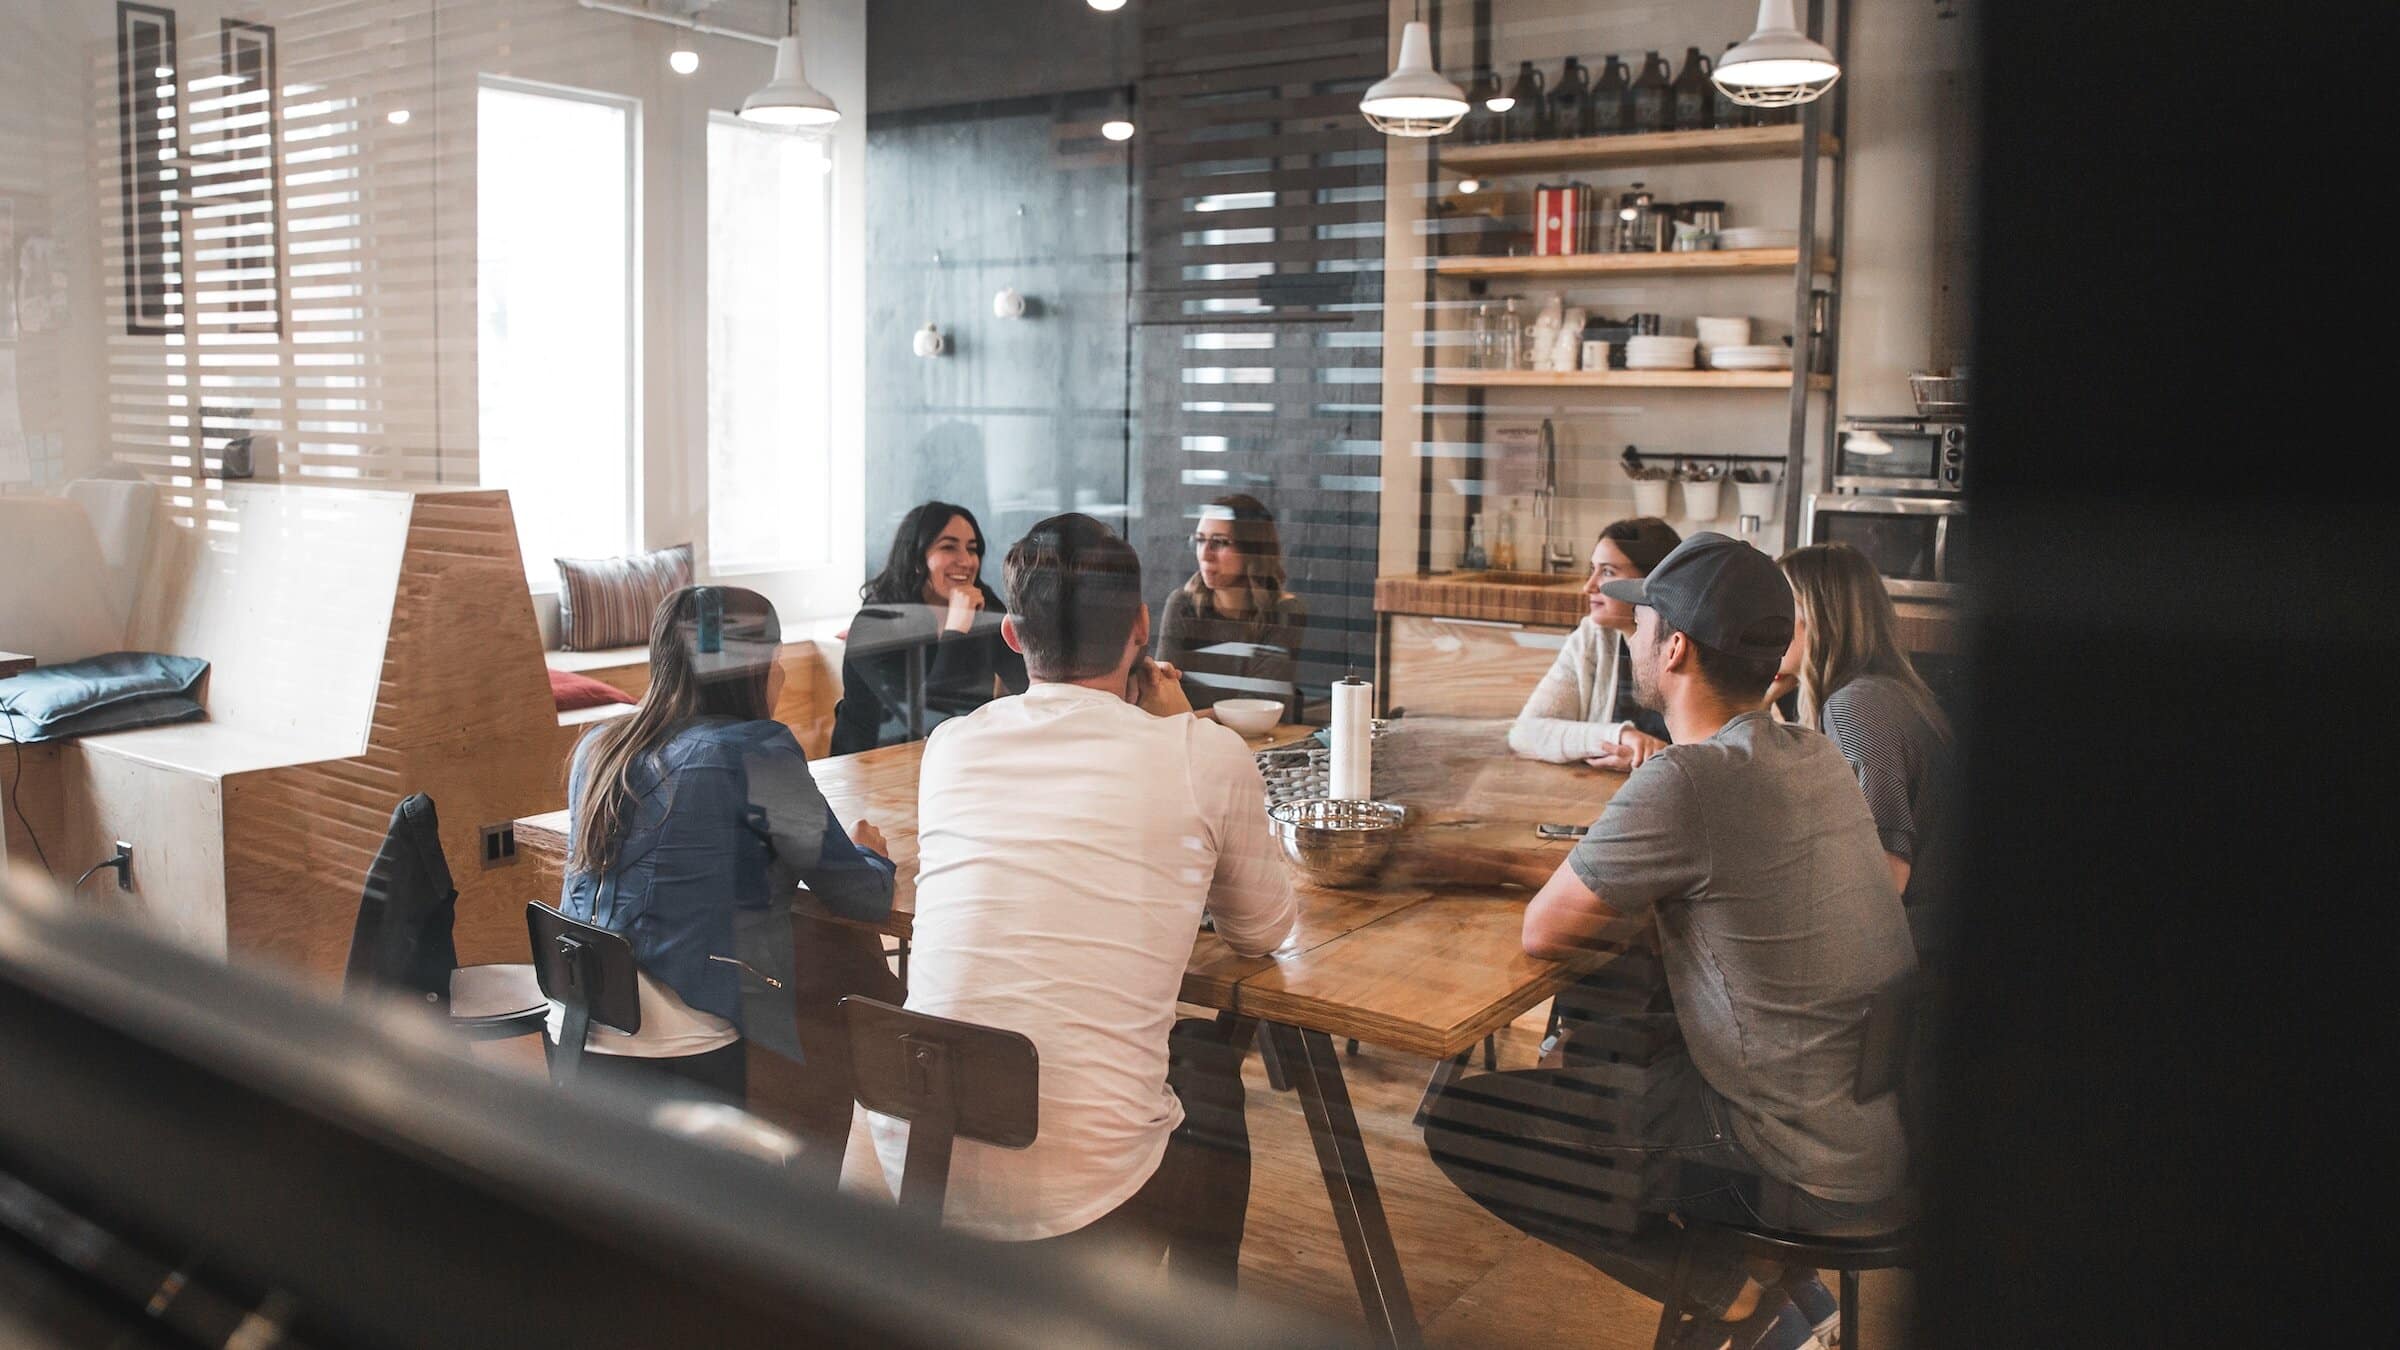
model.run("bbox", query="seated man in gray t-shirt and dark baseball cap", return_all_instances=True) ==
[1409,533,1915,1350]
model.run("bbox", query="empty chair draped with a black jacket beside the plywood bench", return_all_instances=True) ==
[343,793,550,1040]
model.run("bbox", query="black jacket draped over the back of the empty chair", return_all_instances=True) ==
[341,793,458,1009]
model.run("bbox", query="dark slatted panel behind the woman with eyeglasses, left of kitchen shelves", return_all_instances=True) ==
[1135,0,1390,699]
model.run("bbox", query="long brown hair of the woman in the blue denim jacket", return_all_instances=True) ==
[566,586,782,874]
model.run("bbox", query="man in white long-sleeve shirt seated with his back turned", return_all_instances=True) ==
[869,514,1294,1288]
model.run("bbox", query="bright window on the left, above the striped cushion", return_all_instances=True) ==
[475,79,638,584]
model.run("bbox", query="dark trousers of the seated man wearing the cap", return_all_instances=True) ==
[1426,1008,1896,1316]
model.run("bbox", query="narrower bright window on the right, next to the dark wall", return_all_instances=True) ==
[708,115,833,572]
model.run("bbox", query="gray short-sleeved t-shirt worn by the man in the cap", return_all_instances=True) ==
[1567,713,1915,1203]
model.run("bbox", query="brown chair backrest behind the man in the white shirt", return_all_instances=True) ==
[842,994,1042,1223]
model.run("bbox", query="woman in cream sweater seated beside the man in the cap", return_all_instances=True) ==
[1507,516,1682,771]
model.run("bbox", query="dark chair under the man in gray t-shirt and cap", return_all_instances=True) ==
[1654,968,1930,1350]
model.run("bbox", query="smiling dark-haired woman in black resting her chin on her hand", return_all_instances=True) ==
[833,502,1025,754]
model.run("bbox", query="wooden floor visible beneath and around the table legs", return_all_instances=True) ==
[842,1009,1908,1350]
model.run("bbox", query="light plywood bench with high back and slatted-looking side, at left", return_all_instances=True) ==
[7,483,581,980]
